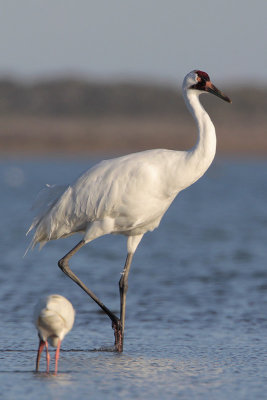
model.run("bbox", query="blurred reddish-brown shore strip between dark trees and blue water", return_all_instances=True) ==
[0,116,267,156]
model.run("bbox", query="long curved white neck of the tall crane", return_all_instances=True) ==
[183,89,216,180]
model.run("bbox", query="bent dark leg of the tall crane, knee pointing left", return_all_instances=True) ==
[58,240,122,352]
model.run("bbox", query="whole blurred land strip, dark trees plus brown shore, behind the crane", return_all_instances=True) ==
[0,78,267,154]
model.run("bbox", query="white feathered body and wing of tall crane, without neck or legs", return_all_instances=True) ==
[26,149,186,252]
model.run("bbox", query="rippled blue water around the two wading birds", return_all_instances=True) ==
[0,158,267,400]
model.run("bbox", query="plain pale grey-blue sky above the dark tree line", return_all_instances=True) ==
[0,0,267,86]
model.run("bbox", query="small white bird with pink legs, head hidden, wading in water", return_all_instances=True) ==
[34,294,75,374]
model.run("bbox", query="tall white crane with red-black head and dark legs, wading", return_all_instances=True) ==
[29,70,231,351]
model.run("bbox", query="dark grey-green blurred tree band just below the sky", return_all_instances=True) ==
[0,79,267,116]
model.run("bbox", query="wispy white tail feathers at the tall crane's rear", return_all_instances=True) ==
[24,185,68,255]
